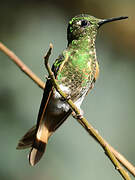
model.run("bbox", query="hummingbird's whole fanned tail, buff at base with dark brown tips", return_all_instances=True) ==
[16,124,49,166]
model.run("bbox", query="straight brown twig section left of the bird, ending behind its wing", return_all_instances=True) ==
[0,42,45,89]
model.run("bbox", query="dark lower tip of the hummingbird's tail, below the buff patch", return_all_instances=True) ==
[29,141,46,166]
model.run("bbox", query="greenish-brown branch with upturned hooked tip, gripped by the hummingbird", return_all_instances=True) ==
[44,44,130,180]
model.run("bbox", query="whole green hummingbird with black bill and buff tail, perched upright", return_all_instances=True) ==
[17,14,128,166]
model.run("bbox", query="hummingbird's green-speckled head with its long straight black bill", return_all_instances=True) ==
[67,14,128,43]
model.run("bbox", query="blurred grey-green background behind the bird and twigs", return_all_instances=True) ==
[0,0,135,180]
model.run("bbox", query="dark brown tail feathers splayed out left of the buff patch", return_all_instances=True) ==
[16,126,36,149]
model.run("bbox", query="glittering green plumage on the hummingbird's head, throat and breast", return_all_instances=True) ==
[54,15,100,101]
